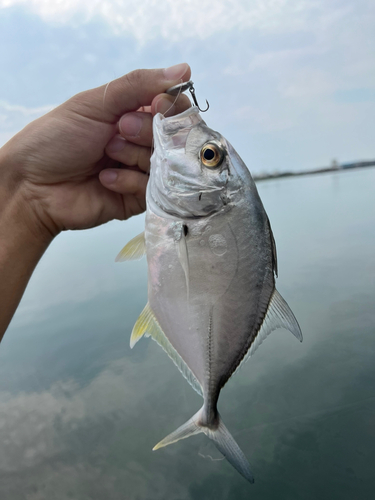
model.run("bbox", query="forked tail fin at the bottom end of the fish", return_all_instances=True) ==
[153,408,254,483]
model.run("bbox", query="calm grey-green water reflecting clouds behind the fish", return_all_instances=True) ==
[0,169,375,500]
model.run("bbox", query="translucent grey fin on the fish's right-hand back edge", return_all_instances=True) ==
[237,288,303,369]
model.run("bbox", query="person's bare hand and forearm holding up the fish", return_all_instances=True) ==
[0,63,190,339]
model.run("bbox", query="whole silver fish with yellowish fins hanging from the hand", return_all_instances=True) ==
[116,106,302,483]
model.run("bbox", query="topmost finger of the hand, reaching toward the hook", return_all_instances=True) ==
[73,63,191,123]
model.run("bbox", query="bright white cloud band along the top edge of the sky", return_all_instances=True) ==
[0,0,334,42]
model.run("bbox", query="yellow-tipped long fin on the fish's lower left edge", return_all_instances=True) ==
[130,303,202,396]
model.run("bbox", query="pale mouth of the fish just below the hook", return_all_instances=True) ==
[153,106,204,150]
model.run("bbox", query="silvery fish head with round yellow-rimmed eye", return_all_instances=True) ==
[147,107,250,218]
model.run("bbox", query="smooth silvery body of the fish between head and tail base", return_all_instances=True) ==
[146,199,274,400]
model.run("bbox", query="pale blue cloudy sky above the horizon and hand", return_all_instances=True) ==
[0,0,375,173]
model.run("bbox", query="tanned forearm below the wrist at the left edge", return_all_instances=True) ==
[0,186,52,340]
